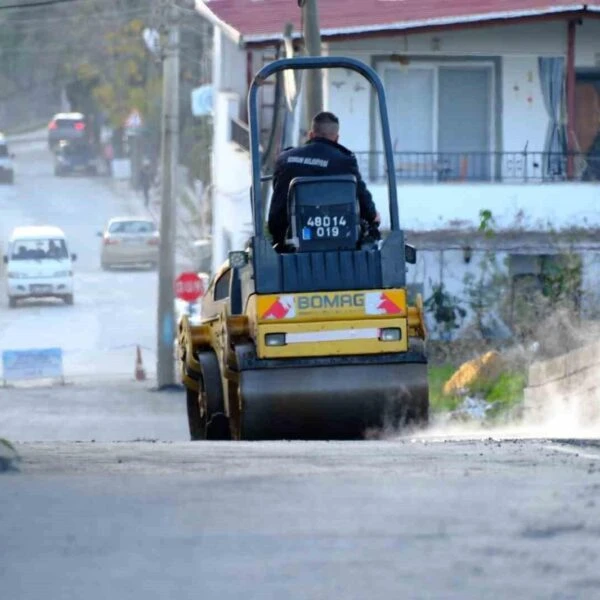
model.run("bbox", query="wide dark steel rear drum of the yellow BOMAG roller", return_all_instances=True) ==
[240,363,429,440]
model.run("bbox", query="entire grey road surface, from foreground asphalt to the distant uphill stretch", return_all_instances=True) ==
[0,132,600,600]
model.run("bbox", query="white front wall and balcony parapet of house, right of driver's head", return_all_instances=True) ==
[324,20,600,230]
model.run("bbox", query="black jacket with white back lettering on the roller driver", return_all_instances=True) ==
[269,138,377,244]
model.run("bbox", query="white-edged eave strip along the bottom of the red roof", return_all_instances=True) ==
[244,4,588,46]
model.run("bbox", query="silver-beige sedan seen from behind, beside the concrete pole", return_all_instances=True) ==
[98,217,160,270]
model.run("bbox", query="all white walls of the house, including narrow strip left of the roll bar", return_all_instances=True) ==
[207,20,600,267]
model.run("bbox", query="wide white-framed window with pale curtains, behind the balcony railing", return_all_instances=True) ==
[380,61,494,180]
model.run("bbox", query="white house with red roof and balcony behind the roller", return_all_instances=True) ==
[197,0,600,328]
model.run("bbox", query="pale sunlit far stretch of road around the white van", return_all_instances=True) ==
[0,136,158,379]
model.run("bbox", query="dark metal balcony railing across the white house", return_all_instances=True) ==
[355,152,600,183]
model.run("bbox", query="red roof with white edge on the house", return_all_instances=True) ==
[197,0,600,47]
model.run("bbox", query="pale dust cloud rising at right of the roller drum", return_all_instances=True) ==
[398,310,600,440]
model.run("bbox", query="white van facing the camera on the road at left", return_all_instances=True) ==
[4,226,77,308]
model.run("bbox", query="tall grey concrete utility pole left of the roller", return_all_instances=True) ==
[156,0,179,389]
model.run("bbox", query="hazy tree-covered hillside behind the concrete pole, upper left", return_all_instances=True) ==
[0,0,211,179]
